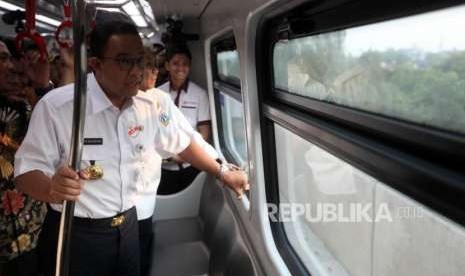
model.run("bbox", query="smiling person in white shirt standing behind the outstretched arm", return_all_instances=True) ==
[158,46,211,195]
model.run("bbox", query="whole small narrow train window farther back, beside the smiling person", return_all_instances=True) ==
[212,33,247,166]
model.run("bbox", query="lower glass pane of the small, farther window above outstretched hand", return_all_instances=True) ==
[219,91,247,166]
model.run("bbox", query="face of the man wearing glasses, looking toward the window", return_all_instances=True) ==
[91,35,144,98]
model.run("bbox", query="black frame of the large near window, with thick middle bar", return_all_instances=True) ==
[255,0,465,275]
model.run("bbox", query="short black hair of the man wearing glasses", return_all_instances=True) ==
[89,20,139,58]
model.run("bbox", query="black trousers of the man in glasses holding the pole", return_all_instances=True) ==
[39,207,140,276]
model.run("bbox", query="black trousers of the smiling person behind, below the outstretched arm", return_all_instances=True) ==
[157,166,200,195]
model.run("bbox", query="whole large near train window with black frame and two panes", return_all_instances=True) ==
[255,0,465,275]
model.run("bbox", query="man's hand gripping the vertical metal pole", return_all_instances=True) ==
[50,166,89,204]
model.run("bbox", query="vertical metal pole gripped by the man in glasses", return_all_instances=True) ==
[55,0,87,276]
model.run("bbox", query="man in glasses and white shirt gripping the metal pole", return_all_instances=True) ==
[15,21,248,276]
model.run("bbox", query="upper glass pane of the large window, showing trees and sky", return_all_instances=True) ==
[273,6,465,133]
